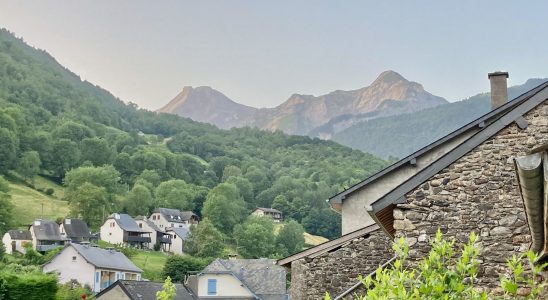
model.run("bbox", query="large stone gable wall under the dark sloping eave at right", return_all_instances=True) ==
[394,101,548,288]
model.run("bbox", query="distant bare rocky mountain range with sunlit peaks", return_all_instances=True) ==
[158,71,447,138]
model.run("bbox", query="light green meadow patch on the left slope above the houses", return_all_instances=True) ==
[9,177,69,226]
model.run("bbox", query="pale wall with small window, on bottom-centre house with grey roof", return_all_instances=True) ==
[198,274,253,298]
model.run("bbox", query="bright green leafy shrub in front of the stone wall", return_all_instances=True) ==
[325,230,548,300]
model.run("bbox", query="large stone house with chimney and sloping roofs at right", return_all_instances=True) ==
[278,72,548,300]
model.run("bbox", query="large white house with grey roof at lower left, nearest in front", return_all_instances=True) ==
[43,243,142,293]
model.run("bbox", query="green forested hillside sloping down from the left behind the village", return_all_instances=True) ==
[0,30,387,255]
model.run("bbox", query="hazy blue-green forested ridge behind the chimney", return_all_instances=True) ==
[330,79,548,158]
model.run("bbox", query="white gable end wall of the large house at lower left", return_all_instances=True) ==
[43,246,95,288]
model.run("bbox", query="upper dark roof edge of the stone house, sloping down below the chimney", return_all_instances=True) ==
[329,82,548,206]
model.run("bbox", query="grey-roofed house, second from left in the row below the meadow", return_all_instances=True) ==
[29,219,68,252]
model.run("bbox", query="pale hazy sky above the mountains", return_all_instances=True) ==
[0,0,548,109]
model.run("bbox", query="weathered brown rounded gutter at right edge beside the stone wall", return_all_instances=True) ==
[514,151,548,260]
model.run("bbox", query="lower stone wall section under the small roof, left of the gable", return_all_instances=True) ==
[290,229,394,300]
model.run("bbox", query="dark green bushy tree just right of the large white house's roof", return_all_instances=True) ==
[162,255,211,282]
